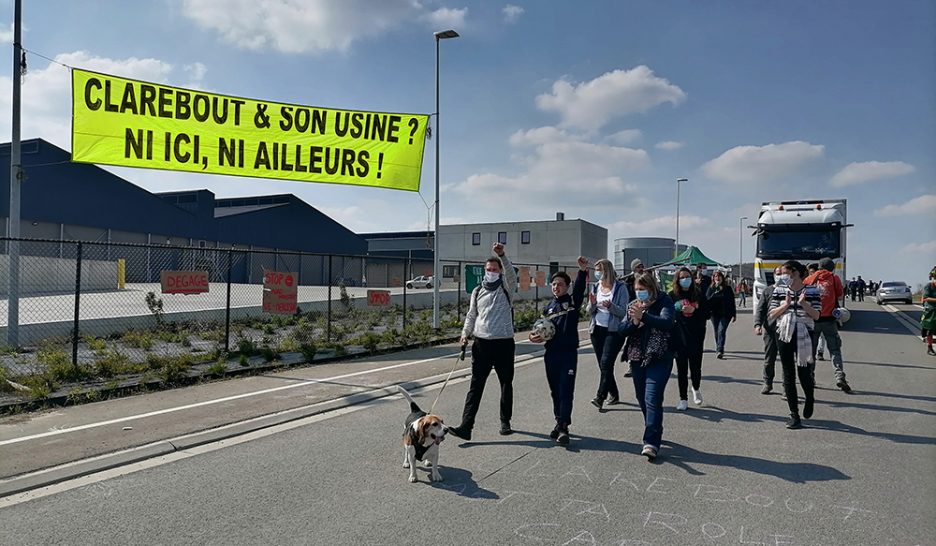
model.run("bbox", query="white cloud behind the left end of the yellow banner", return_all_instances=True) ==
[0,51,204,150]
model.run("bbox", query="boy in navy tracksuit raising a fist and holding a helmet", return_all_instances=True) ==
[530,256,588,445]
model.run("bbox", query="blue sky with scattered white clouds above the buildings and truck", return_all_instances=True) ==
[0,0,936,284]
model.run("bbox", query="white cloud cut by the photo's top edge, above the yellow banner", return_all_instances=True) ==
[182,0,420,53]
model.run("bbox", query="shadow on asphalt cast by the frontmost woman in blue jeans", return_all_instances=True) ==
[654,441,851,483]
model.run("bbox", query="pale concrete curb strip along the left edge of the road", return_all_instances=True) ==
[0,350,545,498]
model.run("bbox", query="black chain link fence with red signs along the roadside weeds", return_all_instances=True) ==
[0,238,575,397]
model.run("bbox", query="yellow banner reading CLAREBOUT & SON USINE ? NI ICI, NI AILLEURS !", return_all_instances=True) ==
[72,69,429,191]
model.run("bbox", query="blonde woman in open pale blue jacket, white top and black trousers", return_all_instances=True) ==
[588,260,630,411]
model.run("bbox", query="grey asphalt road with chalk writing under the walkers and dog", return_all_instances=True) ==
[0,302,936,546]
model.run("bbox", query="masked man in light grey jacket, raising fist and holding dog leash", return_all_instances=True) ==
[449,243,517,440]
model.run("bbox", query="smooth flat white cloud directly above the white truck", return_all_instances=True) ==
[702,140,825,184]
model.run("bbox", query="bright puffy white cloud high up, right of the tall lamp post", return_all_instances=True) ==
[536,66,686,129]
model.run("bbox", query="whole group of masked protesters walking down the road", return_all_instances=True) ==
[450,244,936,459]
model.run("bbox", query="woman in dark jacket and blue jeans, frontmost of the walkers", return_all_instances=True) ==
[618,273,675,460]
